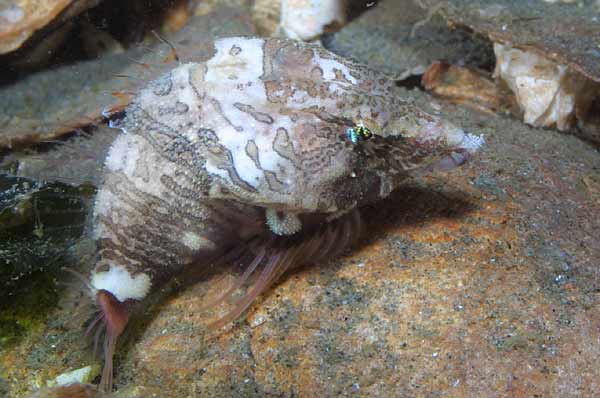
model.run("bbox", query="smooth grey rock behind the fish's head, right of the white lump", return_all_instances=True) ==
[323,0,493,80]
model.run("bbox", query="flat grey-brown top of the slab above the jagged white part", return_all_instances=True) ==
[418,0,600,82]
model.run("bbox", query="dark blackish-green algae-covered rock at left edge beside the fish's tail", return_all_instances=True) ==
[0,174,94,298]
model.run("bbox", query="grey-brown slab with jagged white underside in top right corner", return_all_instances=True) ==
[418,0,600,142]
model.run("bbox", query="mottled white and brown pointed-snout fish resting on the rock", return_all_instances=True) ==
[82,37,483,390]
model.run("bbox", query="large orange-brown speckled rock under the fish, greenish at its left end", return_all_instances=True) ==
[0,0,600,398]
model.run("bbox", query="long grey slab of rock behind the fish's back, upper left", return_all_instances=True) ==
[0,7,253,148]
